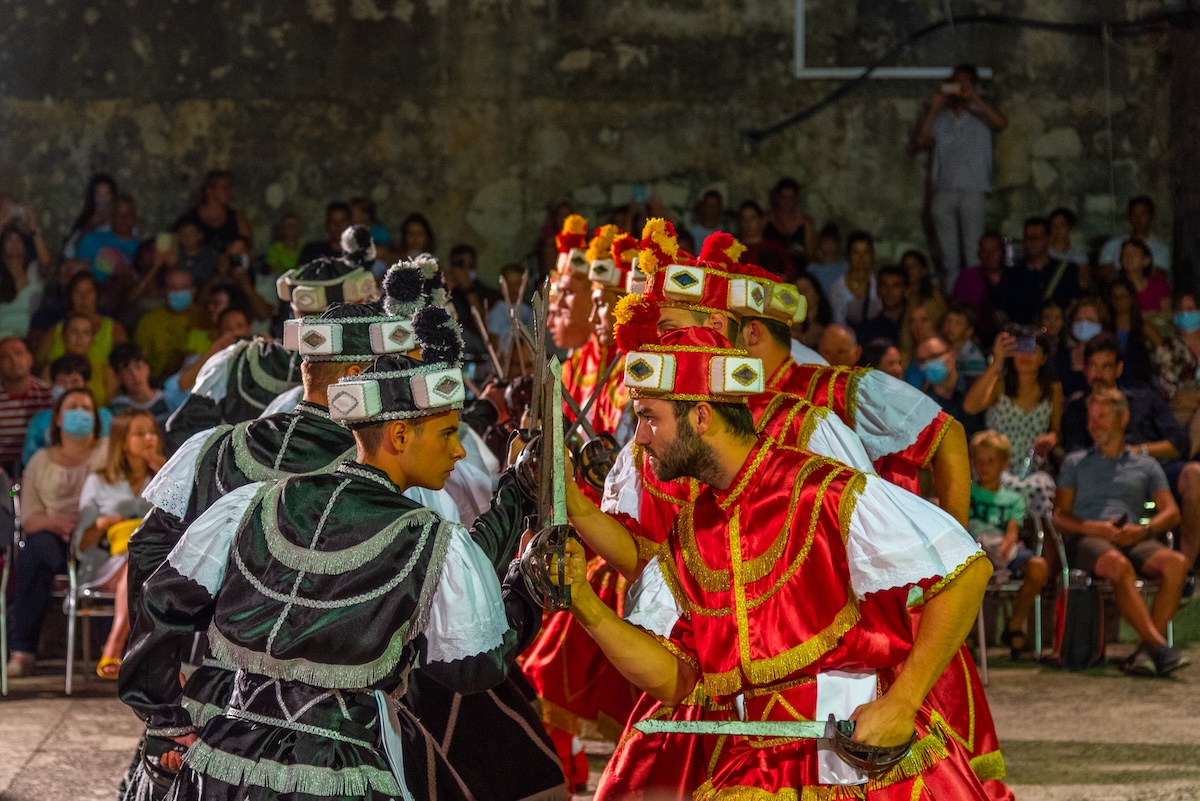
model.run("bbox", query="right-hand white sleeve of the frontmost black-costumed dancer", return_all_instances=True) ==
[425,523,509,662]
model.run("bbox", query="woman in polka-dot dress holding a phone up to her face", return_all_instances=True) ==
[962,329,1062,517]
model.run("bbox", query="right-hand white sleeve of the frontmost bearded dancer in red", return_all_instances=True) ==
[846,476,982,596]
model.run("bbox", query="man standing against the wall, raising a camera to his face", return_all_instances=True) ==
[911,64,1008,289]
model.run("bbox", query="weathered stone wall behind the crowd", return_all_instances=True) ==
[0,0,1170,271]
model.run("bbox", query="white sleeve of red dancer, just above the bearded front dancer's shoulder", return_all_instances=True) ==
[854,369,942,462]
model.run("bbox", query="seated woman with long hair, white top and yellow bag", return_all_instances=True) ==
[73,410,167,681]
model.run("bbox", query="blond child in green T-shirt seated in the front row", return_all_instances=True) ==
[967,430,1050,660]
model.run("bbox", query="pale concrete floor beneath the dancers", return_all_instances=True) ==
[0,644,1200,801]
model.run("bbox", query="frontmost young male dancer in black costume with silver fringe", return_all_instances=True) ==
[136,309,541,801]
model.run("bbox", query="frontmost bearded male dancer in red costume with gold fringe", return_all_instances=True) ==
[556,329,990,800]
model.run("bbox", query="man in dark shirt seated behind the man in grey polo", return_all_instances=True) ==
[1062,335,1200,575]
